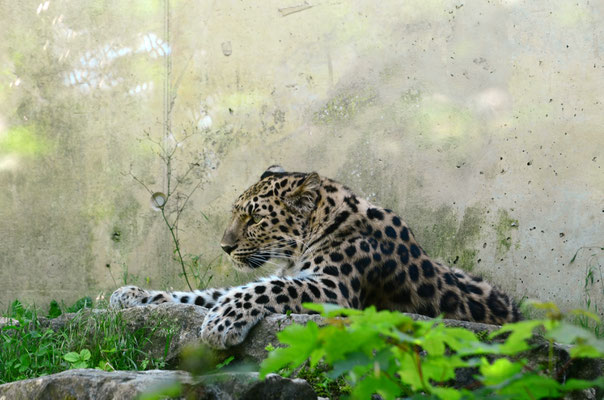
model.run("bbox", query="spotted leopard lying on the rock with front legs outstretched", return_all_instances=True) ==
[110,166,521,349]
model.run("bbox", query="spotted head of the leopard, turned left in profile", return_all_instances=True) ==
[220,166,321,270]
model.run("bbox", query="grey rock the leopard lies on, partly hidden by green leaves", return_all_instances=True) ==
[11,303,604,400]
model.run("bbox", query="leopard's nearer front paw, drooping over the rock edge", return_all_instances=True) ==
[201,303,263,349]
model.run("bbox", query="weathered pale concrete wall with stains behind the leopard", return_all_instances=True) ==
[0,0,604,312]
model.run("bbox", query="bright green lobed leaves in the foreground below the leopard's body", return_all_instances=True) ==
[261,303,604,399]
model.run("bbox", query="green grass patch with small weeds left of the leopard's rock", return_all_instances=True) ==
[0,297,169,384]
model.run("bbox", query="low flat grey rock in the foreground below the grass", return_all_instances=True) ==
[0,369,317,400]
